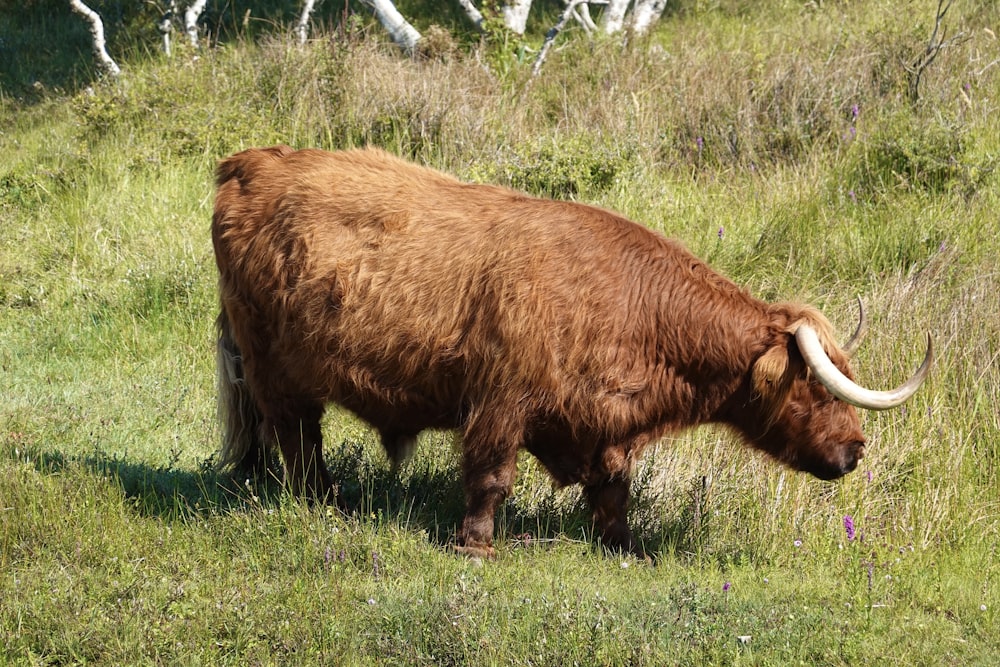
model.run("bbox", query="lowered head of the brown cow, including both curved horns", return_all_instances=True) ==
[744,302,933,479]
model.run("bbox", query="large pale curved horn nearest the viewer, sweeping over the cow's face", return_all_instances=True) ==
[795,324,934,410]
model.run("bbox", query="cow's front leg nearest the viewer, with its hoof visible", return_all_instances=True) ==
[455,411,523,558]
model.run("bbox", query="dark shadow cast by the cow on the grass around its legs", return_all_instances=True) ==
[3,442,692,554]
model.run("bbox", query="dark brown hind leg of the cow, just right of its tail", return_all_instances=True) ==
[262,405,336,502]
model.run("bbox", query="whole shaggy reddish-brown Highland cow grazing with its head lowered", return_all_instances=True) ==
[212,147,931,556]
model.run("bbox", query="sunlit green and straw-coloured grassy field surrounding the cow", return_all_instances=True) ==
[0,0,1000,665]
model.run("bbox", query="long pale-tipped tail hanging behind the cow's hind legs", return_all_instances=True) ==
[215,308,269,476]
